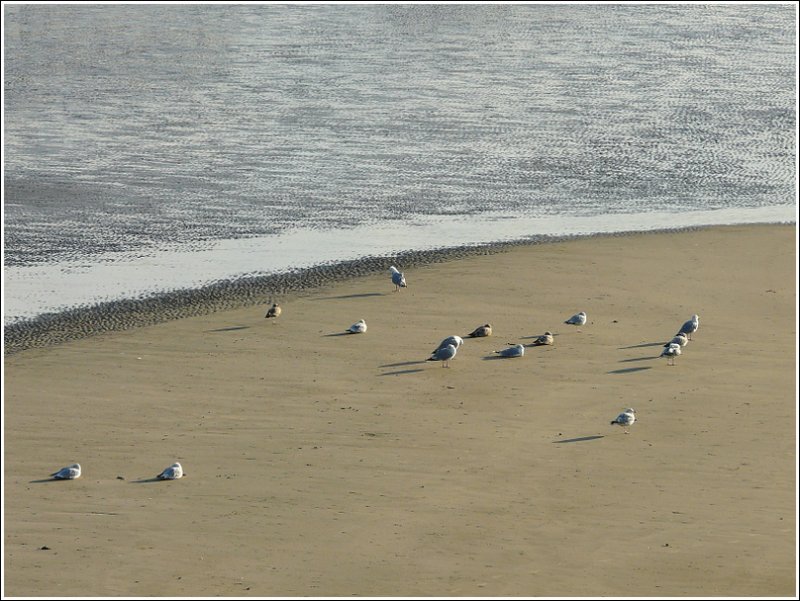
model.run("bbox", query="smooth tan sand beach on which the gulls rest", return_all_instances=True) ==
[4,225,797,597]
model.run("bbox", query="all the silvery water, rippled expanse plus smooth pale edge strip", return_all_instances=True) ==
[3,3,798,324]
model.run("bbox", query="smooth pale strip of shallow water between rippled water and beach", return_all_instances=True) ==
[4,207,797,324]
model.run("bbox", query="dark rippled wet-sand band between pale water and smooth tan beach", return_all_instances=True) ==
[3,222,796,355]
